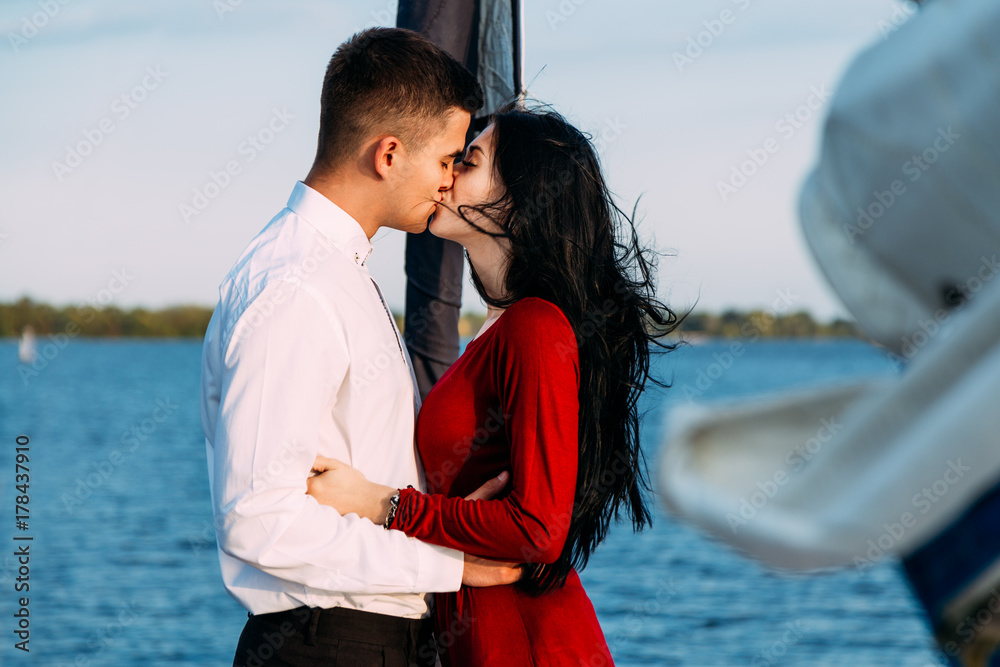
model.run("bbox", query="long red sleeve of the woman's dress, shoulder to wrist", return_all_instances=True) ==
[392,298,580,563]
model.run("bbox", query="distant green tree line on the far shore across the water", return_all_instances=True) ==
[0,297,862,338]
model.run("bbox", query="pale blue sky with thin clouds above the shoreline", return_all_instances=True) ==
[0,0,908,319]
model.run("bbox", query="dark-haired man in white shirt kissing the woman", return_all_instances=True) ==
[201,28,519,667]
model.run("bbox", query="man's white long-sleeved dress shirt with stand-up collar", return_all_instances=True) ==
[201,181,463,618]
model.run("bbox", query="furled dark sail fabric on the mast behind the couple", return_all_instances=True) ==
[396,0,521,398]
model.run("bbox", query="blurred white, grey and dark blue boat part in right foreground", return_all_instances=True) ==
[658,0,1000,666]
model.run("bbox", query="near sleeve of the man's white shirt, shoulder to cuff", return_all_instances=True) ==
[212,280,464,594]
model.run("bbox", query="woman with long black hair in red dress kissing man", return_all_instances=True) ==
[309,105,680,667]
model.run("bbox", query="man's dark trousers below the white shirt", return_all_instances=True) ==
[233,607,436,667]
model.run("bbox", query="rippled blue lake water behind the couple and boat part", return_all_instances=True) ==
[0,337,943,667]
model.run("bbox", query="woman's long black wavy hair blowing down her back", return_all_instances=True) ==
[457,102,687,593]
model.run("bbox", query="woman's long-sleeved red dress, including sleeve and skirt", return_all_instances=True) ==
[392,297,613,667]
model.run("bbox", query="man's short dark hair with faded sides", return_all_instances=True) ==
[316,28,483,175]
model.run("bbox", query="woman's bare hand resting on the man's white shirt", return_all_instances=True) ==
[306,456,398,526]
